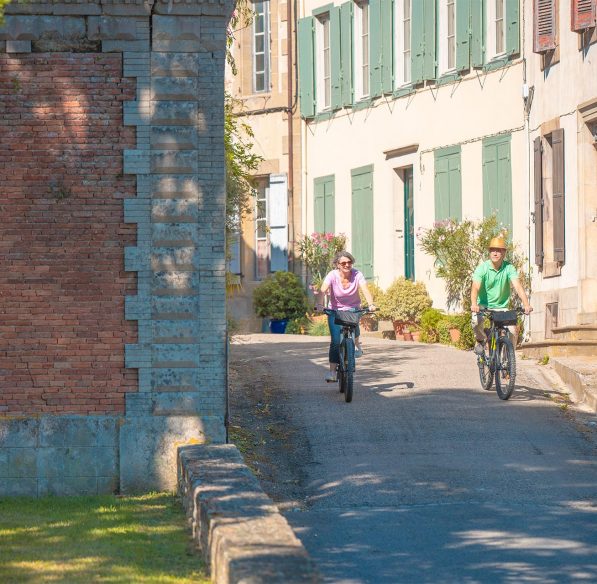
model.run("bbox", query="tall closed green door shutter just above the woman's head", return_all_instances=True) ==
[351,165,373,279]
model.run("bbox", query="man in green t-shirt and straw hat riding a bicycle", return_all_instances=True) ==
[471,237,533,355]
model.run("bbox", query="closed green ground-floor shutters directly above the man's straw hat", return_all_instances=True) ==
[483,136,512,234]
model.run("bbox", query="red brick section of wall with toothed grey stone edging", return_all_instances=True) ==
[0,53,137,414]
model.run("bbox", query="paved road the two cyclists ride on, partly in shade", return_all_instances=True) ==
[232,335,597,584]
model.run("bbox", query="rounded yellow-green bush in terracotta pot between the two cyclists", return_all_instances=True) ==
[378,277,432,338]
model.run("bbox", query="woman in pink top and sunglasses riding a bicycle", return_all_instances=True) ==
[321,250,375,383]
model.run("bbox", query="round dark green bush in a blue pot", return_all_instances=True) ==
[253,272,307,333]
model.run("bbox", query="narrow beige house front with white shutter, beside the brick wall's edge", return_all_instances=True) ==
[227,0,302,332]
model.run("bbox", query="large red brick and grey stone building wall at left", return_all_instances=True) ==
[0,0,232,496]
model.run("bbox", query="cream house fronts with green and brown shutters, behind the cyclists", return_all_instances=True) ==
[298,0,597,340]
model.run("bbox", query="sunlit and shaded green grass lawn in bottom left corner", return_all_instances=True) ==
[0,493,209,584]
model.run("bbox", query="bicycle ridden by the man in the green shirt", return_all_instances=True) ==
[477,308,524,400]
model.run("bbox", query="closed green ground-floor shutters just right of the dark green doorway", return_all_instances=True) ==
[435,146,462,221]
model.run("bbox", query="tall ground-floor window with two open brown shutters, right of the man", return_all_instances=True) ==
[534,129,566,278]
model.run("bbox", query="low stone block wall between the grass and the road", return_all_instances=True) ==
[178,444,320,584]
